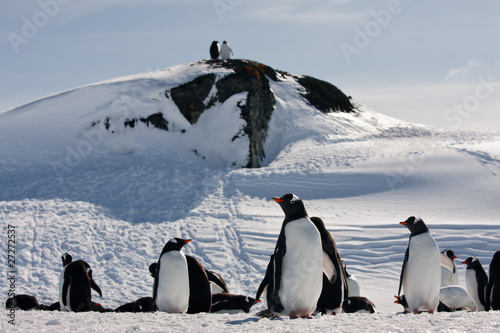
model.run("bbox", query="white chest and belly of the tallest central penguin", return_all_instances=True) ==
[279,218,323,316]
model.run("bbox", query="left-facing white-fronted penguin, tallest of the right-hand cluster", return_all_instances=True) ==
[398,216,441,313]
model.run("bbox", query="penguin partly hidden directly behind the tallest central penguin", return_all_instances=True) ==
[311,217,348,314]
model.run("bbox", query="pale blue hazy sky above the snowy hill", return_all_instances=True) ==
[0,0,500,131]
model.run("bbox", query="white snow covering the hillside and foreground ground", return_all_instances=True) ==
[0,63,500,332]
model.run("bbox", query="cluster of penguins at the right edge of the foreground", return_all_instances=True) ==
[395,216,500,313]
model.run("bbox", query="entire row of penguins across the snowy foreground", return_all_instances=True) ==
[6,193,500,319]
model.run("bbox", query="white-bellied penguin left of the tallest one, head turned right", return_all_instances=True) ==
[153,238,191,313]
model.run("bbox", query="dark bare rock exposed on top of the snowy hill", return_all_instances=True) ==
[91,59,354,168]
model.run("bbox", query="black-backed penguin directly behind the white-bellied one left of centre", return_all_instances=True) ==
[186,256,212,313]
